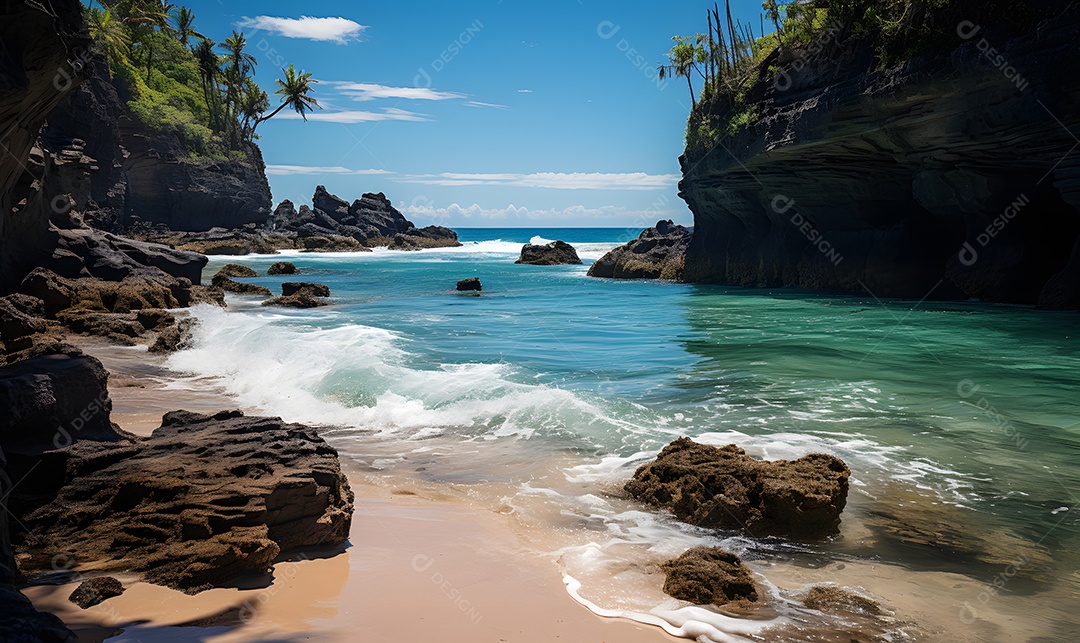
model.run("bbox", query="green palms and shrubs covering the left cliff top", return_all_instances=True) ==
[84,0,319,158]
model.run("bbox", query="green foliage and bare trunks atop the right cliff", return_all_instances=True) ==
[661,0,1037,157]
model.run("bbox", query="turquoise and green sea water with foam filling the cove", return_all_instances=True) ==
[171,229,1080,641]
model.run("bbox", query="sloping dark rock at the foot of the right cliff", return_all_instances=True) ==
[589,220,691,281]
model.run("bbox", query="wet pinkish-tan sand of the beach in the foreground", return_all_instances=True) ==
[24,338,680,643]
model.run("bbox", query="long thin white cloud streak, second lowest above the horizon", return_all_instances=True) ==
[402,172,681,190]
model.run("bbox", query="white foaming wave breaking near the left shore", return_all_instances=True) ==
[168,306,620,439]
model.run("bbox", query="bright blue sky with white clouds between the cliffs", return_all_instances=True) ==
[177,0,760,227]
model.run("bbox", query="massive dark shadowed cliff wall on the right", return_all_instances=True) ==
[679,3,1080,308]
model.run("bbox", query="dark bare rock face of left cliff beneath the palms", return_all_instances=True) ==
[41,55,271,232]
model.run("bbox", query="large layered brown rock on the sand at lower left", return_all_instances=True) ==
[17,411,353,591]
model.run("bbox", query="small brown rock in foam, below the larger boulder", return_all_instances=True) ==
[660,547,757,605]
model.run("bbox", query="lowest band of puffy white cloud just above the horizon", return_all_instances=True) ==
[399,203,678,227]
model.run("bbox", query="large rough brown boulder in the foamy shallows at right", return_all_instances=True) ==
[625,438,851,538]
